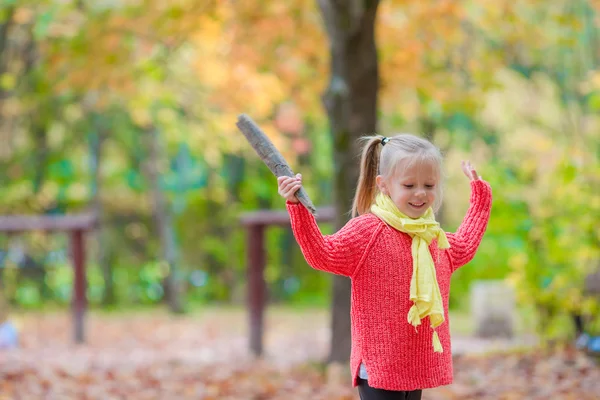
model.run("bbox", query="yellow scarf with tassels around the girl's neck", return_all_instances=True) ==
[371,193,450,353]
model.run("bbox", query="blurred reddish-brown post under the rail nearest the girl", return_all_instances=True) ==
[247,224,267,356]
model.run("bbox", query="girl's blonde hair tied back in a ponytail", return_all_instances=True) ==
[352,133,443,217]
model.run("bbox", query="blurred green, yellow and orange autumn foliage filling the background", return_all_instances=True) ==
[0,0,600,346]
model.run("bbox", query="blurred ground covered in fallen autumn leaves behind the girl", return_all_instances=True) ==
[0,309,600,400]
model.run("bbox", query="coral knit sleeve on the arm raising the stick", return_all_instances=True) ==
[286,202,376,277]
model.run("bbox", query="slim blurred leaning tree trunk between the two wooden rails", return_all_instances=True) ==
[144,127,184,313]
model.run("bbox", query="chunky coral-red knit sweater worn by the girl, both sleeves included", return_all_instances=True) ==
[287,180,492,391]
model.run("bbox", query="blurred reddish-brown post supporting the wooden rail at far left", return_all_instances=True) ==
[71,230,87,343]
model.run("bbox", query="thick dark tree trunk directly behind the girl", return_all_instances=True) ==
[319,0,379,363]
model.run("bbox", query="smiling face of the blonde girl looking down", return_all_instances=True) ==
[376,160,439,218]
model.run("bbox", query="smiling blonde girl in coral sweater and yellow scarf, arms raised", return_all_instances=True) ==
[277,134,492,400]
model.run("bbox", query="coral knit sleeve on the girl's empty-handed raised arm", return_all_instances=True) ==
[447,180,492,270]
